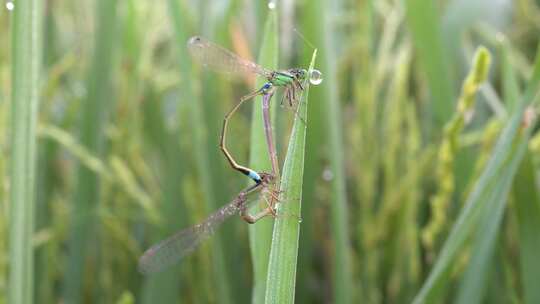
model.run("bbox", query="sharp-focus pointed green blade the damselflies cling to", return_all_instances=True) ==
[265,50,317,303]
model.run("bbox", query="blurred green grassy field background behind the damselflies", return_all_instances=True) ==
[0,0,540,304]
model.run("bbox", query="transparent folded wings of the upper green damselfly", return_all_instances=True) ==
[187,36,272,78]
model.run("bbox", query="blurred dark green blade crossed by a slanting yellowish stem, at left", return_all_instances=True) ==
[64,0,117,303]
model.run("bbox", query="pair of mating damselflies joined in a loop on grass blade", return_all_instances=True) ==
[139,36,322,274]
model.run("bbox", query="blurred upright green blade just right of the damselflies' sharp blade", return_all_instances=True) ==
[308,0,353,304]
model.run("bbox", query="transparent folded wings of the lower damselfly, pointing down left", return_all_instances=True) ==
[138,190,258,274]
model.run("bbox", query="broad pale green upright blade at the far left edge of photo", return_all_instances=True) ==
[8,0,42,304]
